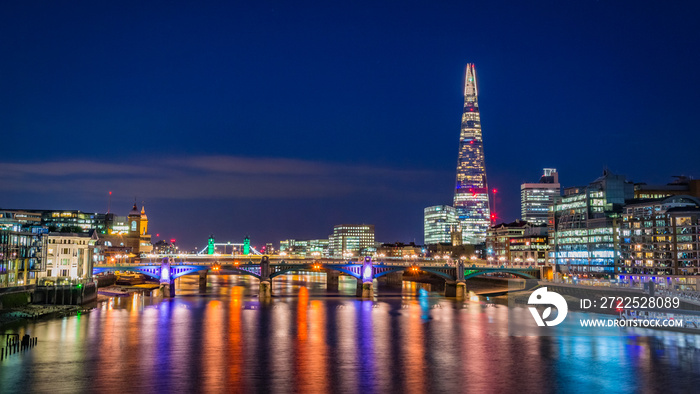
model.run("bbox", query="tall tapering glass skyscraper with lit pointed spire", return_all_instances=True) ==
[454,63,491,244]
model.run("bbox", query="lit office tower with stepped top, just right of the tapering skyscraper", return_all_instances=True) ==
[520,168,561,225]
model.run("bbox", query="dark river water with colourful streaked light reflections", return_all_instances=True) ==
[0,274,700,393]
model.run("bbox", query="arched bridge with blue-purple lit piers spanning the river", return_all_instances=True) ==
[93,255,540,298]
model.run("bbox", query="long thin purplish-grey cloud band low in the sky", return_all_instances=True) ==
[0,156,446,199]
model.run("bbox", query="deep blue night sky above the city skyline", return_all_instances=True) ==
[0,0,700,248]
